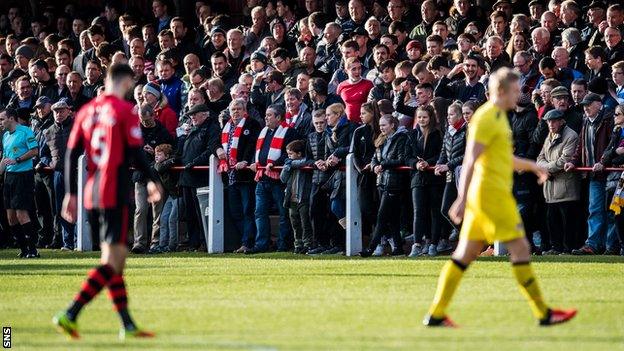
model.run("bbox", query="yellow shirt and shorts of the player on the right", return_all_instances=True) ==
[462,101,524,243]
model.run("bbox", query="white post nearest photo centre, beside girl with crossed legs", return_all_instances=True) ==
[345,154,362,256]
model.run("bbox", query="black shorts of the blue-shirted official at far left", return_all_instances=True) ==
[2,171,35,211]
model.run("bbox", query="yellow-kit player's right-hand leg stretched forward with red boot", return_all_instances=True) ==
[505,237,577,326]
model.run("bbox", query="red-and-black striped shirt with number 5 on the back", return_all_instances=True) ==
[67,95,143,210]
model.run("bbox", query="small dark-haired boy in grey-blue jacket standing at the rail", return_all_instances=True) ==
[280,140,312,254]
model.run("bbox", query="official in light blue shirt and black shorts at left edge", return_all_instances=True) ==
[0,108,39,258]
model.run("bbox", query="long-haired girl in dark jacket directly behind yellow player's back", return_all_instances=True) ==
[434,102,468,248]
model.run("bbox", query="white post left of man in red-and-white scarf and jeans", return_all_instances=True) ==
[206,155,224,254]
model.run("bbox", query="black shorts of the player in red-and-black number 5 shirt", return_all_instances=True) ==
[87,206,128,245]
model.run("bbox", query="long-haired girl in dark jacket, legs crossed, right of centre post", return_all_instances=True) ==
[360,115,408,257]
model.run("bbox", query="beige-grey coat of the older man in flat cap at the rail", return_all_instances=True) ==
[537,126,581,203]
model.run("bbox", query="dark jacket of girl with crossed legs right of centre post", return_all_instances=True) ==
[371,129,408,192]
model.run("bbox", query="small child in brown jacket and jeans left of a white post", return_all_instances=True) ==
[154,144,178,252]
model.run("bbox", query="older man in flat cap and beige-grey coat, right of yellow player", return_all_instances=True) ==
[537,109,581,255]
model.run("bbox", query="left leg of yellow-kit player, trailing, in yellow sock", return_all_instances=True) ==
[423,238,484,327]
